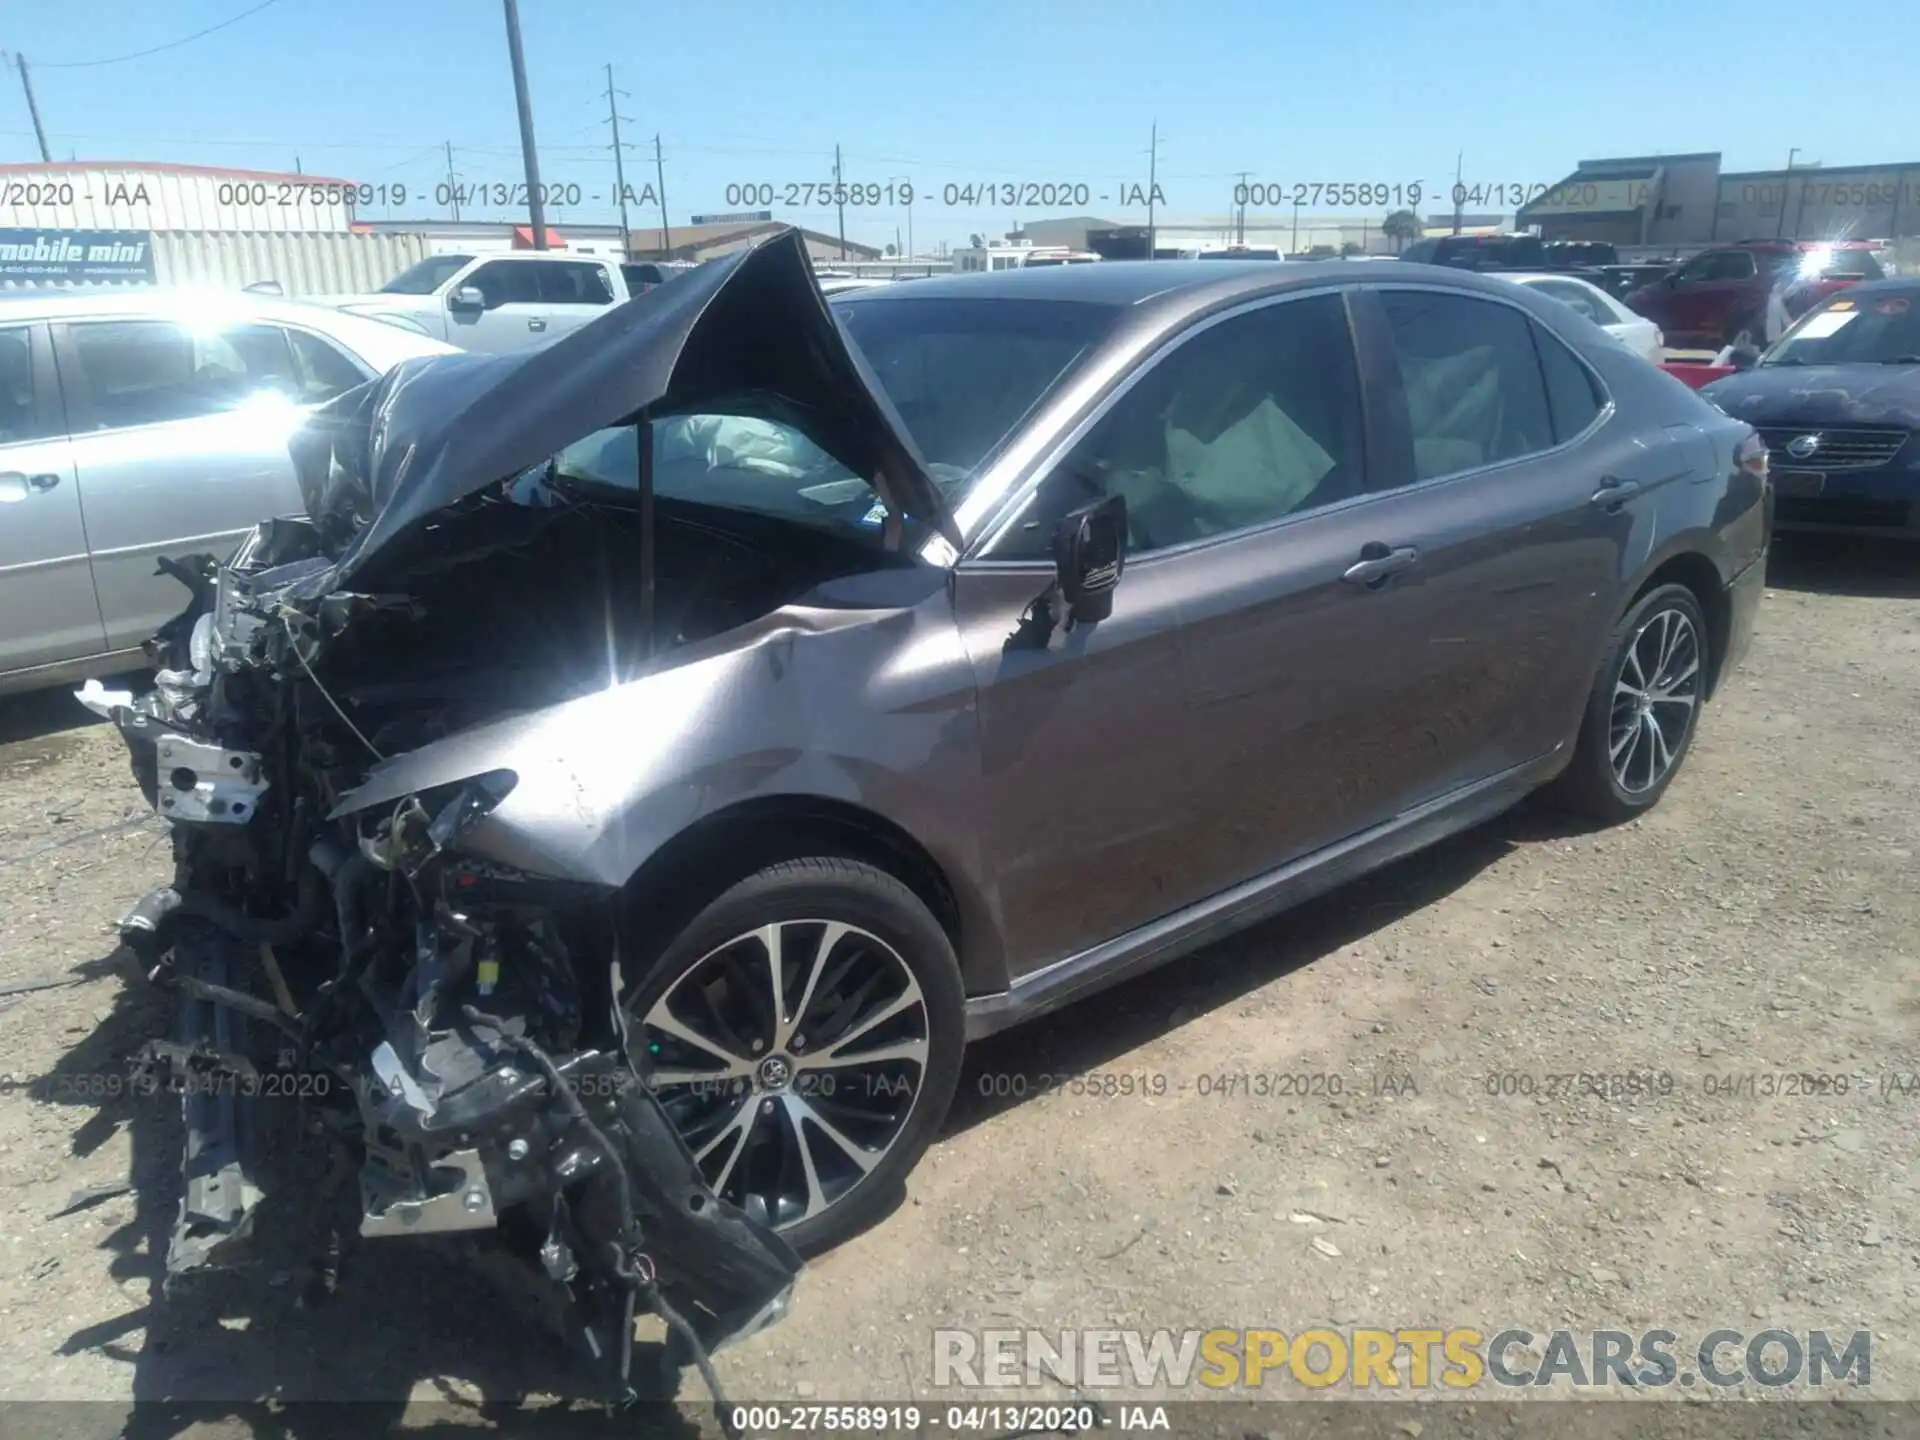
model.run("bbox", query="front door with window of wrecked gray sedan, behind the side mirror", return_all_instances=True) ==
[960,294,1398,973]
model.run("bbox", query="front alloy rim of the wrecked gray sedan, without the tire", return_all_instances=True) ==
[639,920,929,1229]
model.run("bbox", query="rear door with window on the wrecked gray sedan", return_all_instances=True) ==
[1356,286,1651,791]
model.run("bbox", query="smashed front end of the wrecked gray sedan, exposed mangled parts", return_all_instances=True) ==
[108,522,799,1398]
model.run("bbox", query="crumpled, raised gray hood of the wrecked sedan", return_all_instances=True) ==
[288,228,960,589]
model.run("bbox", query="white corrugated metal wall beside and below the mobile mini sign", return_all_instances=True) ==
[0,230,428,298]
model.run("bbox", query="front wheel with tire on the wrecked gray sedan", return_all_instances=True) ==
[626,856,966,1254]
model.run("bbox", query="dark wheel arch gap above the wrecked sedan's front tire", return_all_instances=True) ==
[622,795,1006,995]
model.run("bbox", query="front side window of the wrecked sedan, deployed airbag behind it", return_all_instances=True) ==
[991,296,1365,559]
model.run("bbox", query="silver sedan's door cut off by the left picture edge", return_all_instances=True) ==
[0,324,106,672]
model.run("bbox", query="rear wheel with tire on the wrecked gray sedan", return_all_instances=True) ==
[1555,586,1713,826]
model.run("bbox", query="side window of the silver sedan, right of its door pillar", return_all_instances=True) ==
[69,321,300,430]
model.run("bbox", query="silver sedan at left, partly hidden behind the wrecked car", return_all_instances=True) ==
[0,290,457,693]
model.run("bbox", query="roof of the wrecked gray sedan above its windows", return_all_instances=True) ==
[825,259,1528,305]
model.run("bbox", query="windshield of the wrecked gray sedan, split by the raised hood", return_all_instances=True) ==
[541,300,1117,543]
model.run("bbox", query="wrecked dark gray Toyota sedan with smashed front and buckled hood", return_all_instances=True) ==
[97,230,1768,1397]
